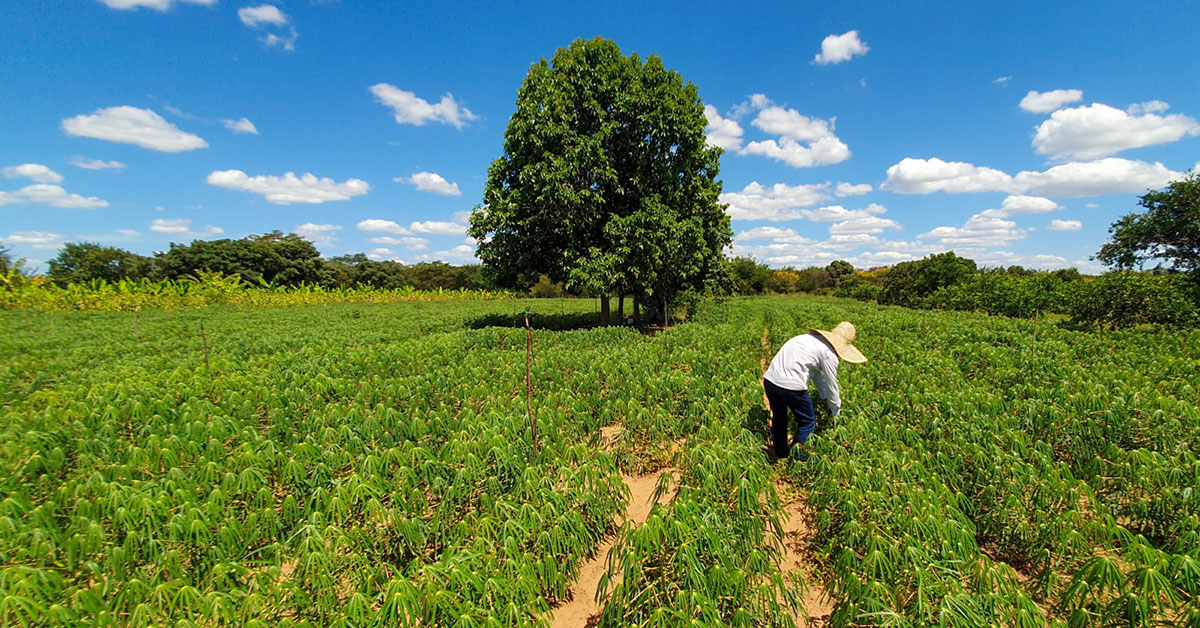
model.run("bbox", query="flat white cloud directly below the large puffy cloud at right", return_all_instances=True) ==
[1015,157,1182,197]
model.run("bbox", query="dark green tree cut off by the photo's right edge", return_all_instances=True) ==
[1096,171,1200,277]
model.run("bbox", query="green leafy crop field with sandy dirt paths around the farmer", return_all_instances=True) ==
[0,298,1200,628]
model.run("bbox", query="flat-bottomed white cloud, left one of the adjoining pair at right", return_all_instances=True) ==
[880,157,1024,195]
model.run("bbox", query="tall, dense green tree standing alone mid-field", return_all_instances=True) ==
[469,37,732,321]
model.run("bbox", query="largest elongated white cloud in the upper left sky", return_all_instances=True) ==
[62,106,209,152]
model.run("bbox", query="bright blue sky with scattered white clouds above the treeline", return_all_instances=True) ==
[0,0,1200,270]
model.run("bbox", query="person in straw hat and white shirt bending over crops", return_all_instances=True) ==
[762,321,866,461]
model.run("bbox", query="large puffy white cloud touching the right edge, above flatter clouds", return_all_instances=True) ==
[1033,103,1200,160]
